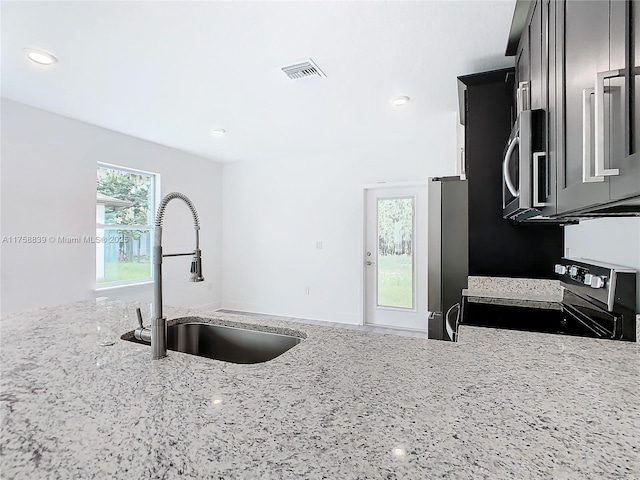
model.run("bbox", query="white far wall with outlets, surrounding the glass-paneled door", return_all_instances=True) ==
[223,112,456,324]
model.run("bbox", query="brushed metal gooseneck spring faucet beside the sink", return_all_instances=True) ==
[134,192,204,360]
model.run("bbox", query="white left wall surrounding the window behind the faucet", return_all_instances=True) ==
[0,99,222,313]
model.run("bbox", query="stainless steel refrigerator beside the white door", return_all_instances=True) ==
[428,177,469,340]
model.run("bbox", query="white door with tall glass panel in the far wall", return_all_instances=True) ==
[364,185,427,330]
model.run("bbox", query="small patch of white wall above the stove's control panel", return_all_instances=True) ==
[564,218,640,312]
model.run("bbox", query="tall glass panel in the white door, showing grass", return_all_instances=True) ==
[376,198,415,309]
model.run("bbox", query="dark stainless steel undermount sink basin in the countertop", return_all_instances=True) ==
[127,322,302,363]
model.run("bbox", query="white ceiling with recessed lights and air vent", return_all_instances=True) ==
[1,0,515,162]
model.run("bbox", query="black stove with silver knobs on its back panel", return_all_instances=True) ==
[455,258,636,341]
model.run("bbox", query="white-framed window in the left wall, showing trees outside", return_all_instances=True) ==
[95,164,158,288]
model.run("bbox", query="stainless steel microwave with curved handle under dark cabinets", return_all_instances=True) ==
[502,110,551,221]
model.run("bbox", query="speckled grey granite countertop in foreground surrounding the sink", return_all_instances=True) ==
[0,302,640,480]
